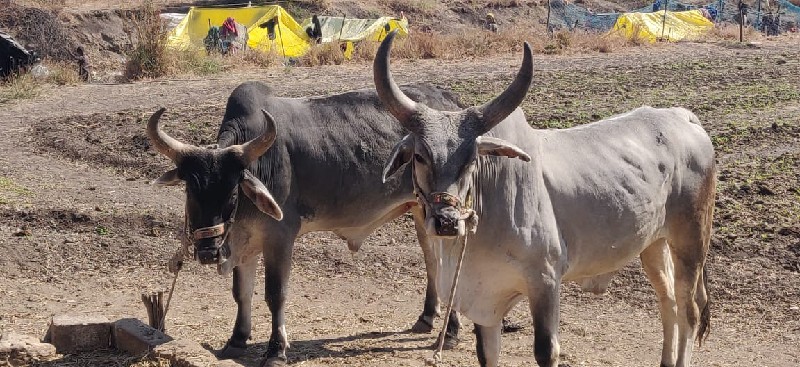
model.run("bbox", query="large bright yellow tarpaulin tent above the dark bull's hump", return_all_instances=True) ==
[167,5,309,57]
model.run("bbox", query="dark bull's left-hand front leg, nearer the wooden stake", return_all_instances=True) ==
[217,256,258,359]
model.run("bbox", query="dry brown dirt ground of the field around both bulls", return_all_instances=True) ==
[0,38,800,366]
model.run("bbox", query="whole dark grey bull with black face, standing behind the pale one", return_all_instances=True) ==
[147,82,466,366]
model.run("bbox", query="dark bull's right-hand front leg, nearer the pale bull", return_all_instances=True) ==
[261,238,294,367]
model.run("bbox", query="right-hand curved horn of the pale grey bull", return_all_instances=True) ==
[479,42,533,133]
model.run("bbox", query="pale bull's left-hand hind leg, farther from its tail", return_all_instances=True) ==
[641,239,678,367]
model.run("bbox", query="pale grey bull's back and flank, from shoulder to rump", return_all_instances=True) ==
[538,107,714,278]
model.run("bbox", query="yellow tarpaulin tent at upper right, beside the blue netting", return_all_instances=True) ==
[611,10,714,42]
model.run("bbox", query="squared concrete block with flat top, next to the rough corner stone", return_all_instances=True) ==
[45,315,111,353]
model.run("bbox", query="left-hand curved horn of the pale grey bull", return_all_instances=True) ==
[372,30,417,131]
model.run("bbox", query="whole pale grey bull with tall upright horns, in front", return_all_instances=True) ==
[374,34,716,367]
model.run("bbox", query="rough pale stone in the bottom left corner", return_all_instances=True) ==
[0,333,58,367]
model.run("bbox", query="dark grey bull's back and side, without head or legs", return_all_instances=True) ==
[219,83,459,229]
